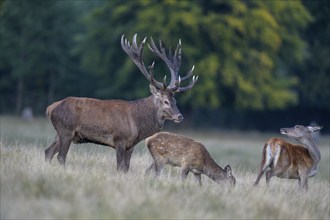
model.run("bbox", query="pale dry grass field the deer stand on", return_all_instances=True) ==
[0,117,330,219]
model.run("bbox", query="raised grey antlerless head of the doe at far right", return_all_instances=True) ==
[280,125,322,140]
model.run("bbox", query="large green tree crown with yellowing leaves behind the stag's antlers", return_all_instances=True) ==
[76,1,311,110]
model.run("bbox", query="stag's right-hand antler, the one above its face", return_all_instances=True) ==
[148,38,198,92]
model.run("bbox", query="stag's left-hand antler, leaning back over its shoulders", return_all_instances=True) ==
[121,34,166,90]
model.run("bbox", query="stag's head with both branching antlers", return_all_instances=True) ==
[121,34,198,123]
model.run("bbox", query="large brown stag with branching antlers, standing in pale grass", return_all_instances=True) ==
[45,34,198,173]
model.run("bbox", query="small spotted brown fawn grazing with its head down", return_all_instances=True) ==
[146,132,236,186]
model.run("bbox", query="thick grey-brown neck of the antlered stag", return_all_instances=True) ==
[132,96,164,140]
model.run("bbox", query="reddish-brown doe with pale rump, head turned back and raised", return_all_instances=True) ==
[254,125,322,190]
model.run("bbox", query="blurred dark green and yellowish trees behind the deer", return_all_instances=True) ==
[0,0,330,133]
